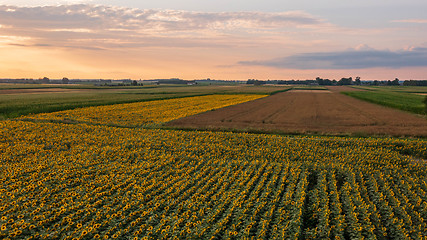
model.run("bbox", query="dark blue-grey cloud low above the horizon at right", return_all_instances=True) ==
[239,46,427,69]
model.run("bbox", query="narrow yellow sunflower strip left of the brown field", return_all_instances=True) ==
[25,94,266,127]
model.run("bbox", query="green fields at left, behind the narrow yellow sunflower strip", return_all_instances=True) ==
[0,84,289,120]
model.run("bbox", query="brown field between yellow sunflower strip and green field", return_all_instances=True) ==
[167,87,427,137]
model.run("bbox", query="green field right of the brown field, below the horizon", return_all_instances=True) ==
[343,86,427,114]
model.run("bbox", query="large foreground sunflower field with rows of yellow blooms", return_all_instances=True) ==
[0,121,427,239]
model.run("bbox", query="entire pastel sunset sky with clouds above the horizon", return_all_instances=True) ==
[0,0,427,80]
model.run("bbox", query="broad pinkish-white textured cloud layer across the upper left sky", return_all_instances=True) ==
[0,4,329,49]
